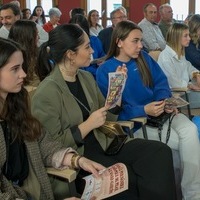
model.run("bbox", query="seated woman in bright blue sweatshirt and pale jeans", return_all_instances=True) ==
[97,21,200,199]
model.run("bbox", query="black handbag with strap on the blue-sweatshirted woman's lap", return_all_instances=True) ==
[146,112,175,144]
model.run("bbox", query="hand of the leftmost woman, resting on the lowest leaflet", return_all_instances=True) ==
[78,157,105,177]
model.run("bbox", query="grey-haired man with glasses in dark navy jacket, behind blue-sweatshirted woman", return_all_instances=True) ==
[98,7,127,53]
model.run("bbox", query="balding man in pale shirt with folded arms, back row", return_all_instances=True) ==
[138,3,166,51]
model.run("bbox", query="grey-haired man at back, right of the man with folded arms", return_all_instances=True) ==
[158,3,175,38]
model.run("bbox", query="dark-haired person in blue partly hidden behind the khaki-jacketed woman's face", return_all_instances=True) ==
[70,14,105,79]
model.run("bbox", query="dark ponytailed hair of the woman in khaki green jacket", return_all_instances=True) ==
[36,24,84,80]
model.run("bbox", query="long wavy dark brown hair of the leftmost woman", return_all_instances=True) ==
[0,38,41,141]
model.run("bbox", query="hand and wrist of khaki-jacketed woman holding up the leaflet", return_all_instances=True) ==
[78,107,107,138]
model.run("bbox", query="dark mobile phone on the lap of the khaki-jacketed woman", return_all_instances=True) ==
[105,135,128,155]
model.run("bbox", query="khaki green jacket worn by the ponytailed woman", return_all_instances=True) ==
[31,66,117,154]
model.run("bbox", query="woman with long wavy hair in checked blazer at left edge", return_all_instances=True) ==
[0,38,104,200]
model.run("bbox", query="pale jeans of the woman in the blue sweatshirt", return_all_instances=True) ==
[134,113,200,200]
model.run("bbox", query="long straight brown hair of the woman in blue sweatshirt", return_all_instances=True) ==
[106,20,153,86]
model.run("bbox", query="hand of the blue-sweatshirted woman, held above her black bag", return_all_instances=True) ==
[144,100,165,117]
